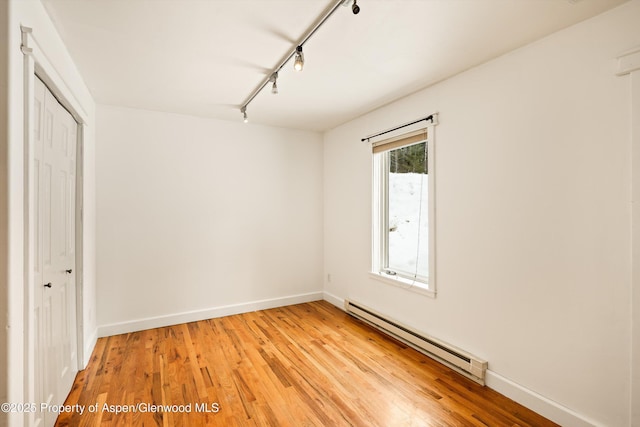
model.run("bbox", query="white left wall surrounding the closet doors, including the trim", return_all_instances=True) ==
[0,0,96,426]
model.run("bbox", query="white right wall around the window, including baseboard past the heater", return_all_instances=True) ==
[324,0,640,426]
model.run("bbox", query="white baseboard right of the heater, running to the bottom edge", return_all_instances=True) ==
[486,370,604,427]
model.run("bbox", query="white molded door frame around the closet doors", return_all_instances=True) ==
[20,26,88,425]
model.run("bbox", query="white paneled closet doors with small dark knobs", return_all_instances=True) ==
[33,78,78,426]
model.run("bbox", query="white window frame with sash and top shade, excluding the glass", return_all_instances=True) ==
[370,115,437,298]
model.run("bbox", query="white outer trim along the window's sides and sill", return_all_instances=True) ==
[369,113,438,298]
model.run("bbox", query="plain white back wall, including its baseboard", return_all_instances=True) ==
[96,106,323,335]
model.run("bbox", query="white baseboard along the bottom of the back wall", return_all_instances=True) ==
[98,291,323,337]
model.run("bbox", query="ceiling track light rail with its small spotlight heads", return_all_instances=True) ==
[240,0,360,123]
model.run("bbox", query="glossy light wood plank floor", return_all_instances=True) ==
[56,301,556,427]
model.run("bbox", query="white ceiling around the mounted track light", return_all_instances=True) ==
[42,0,625,131]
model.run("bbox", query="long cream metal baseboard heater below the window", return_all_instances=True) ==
[344,300,488,385]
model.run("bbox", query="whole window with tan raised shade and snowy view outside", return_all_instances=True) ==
[372,127,435,295]
